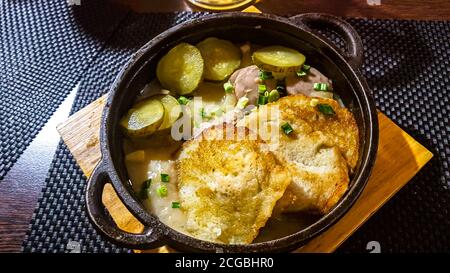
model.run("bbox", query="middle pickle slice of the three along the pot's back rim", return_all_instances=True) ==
[197,37,241,81]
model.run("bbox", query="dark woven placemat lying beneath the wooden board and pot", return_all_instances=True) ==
[23,13,450,252]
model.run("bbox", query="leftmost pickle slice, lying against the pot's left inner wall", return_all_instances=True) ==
[120,98,164,137]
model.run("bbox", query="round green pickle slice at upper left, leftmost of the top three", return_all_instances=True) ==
[156,43,204,95]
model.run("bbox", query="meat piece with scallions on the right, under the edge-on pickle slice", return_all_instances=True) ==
[286,67,332,97]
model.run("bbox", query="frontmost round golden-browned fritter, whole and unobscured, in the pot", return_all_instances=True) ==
[176,126,291,244]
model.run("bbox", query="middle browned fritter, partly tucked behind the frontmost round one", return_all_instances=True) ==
[276,138,349,214]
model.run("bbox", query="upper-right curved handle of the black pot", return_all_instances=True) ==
[289,13,364,68]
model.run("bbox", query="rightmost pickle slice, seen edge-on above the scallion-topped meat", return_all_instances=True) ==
[252,46,305,73]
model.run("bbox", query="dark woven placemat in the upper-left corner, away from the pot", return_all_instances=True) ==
[0,0,126,180]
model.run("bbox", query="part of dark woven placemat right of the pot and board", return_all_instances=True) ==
[339,19,450,252]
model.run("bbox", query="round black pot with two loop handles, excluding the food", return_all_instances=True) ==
[86,12,378,252]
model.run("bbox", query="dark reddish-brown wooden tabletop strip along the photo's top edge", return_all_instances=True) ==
[111,0,450,20]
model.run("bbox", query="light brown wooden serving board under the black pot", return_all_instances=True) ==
[58,93,433,252]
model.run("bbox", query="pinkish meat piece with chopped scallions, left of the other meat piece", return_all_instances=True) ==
[230,65,276,105]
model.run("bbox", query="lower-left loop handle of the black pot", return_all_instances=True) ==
[86,162,164,249]
